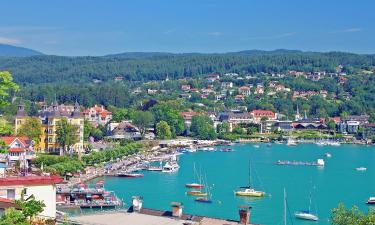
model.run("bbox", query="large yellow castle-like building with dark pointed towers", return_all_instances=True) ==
[15,100,84,152]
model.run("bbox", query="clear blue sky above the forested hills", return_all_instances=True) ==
[0,0,375,55]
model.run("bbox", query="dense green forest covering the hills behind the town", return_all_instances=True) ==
[0,50,375,117]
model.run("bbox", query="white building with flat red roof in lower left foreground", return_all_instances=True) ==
[0,176,62,218]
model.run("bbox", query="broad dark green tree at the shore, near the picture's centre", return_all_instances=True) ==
[190,115,217,140]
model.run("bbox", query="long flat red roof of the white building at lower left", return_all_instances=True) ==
[0,176,63,186]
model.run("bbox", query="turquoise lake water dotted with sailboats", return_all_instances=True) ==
[87,144,375,225]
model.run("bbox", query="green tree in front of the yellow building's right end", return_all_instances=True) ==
[56,118,79,156]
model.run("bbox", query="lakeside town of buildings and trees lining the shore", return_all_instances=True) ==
[0,67,375,224]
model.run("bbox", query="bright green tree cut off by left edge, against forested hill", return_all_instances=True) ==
[0,71,19,107]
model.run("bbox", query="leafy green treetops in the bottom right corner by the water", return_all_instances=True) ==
[331,204,375,225]
